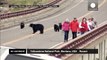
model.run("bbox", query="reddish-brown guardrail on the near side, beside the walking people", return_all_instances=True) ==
[50,21,107,58]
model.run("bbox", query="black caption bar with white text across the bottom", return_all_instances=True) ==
[9,49,98,54]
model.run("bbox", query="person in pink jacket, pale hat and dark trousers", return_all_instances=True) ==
[62,19,70,42]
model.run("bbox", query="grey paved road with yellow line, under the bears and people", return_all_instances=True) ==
[0,0,107,48]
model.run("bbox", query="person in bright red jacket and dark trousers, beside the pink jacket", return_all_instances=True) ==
[70,18,79,39]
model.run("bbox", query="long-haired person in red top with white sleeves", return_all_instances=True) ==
[79,17,89,34]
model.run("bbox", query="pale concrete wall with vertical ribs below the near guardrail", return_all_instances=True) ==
[66,35,107,60]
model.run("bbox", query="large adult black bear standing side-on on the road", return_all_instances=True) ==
[30,24,44,34]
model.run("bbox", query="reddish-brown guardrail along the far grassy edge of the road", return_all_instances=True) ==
[0,0,62,20]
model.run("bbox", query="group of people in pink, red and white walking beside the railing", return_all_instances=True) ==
[62,17,96,42]
